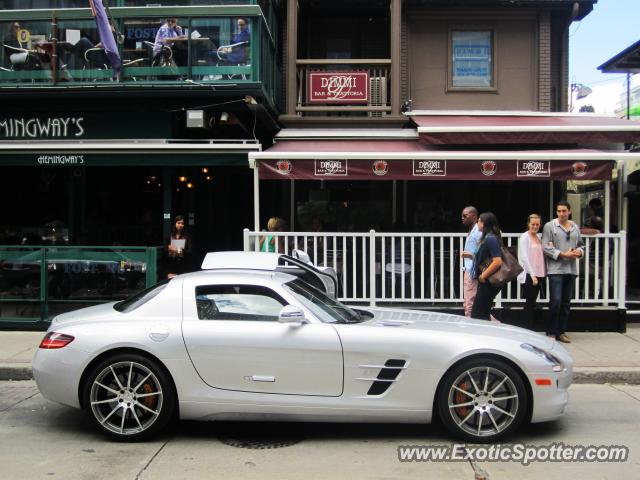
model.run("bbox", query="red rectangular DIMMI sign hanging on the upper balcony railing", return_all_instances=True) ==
[307,71,369,104]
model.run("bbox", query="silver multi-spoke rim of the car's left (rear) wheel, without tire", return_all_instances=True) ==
[89,361,164,435]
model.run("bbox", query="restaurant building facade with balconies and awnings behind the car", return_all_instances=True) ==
[0,0,640,325]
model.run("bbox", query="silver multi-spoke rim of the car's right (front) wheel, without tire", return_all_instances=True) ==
[447,366,521,437]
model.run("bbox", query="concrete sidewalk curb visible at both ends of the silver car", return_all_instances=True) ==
[0,363,640,385]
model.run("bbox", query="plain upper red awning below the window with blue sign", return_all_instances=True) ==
[410,112,640,145]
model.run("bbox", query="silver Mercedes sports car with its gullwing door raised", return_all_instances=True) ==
[33,252,573,442]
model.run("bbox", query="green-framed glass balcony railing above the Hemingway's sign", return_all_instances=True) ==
[0,5,278,102]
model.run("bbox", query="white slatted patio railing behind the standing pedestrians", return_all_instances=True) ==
[244,229,626,308]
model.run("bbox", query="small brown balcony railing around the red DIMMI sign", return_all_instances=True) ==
[296,59,393,117]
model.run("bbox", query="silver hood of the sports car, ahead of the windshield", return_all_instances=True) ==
[358,307,556,350]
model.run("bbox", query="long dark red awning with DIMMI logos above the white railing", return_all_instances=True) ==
[249,140,633,181]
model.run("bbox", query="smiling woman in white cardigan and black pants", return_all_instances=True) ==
[518,213,546,328]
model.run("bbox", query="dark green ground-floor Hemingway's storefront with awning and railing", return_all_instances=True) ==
[0,112,260,328]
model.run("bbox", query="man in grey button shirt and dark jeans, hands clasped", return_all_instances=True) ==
[542,201,584,343]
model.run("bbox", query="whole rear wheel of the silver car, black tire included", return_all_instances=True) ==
[82,353,177,442]
